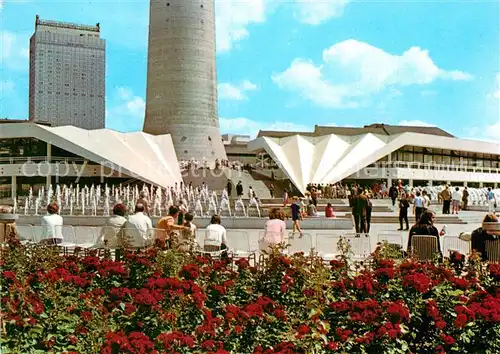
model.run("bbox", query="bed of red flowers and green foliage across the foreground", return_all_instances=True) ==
[0,239,500,353]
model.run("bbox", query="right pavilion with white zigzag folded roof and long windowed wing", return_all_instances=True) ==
[248,124,500,193]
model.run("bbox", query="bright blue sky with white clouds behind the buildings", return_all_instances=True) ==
[0,0,500,140]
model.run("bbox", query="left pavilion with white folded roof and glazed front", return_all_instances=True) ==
[0,121,182,204]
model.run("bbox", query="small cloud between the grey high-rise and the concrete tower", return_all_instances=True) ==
[106,87,146,131]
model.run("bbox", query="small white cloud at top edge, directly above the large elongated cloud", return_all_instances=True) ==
[294,0,349,25]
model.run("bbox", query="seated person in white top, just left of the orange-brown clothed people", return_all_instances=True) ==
[123,203,153,248]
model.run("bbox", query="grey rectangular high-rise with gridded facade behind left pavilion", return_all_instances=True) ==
[29,15,106,129]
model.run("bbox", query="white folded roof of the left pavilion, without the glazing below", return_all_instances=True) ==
[0,122,182,188]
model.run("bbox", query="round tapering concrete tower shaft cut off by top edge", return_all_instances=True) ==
[144,0,226,165]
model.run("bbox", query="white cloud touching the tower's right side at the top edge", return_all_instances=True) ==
[215,0,267,52]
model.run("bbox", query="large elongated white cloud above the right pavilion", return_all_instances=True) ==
[272,39,472,108]
